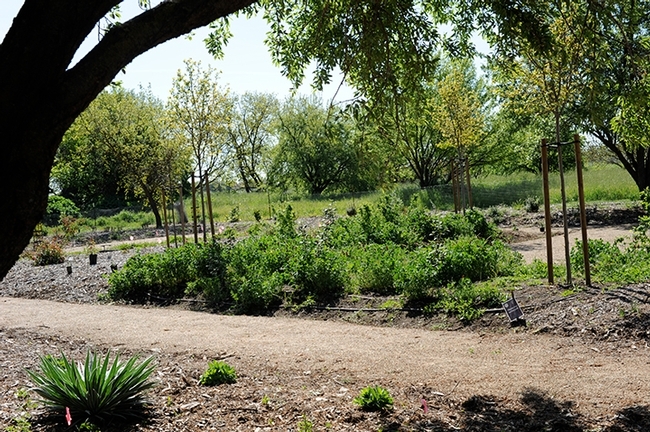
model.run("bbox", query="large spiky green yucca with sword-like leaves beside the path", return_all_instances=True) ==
[27,351,155,421]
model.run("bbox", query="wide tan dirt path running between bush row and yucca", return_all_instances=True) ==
[0,298,650,413]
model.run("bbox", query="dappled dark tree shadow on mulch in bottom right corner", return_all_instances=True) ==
[381,389,650,432]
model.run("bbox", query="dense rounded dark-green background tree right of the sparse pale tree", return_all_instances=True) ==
[270,97,357,195]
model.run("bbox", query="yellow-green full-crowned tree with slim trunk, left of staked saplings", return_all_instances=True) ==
[62,88,189,228]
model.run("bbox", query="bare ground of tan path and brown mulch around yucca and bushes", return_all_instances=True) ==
[0,208,650,432]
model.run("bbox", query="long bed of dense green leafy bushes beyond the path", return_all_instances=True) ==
[109,199,521,317]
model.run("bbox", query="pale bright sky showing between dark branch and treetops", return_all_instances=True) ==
[0,0,352,101]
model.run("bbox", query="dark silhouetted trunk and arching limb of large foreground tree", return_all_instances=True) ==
[0,0,255,278]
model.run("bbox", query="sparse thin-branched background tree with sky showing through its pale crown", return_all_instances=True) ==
[227,93,278,192]
